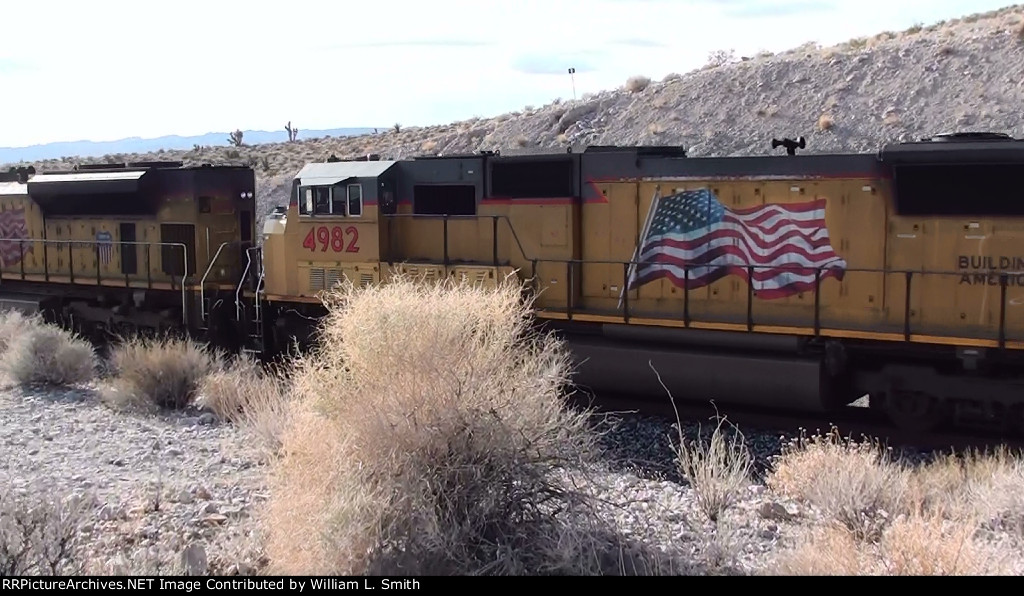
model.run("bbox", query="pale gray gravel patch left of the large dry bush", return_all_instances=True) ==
[0,388,266,573]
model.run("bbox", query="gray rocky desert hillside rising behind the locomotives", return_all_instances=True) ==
[6,5,1024,224]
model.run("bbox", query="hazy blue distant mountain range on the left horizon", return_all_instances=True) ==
[0,127,387,164]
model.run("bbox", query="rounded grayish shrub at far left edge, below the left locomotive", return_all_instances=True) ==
[3,318,98,385]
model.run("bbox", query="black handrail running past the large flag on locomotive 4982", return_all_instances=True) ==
[530,259,1024,349]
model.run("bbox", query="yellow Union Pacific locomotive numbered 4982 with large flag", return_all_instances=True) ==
[254,134,1024,434]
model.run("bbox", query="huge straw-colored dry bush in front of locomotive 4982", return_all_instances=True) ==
[266,278,652,574]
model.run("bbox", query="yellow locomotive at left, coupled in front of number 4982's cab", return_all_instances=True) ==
[0,162,256,342]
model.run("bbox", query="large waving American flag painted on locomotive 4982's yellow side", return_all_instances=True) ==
[629,188,846,299]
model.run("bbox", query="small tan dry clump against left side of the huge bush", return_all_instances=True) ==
[197,356,289,452]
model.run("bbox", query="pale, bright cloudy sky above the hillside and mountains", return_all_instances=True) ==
[0,0,1013,146]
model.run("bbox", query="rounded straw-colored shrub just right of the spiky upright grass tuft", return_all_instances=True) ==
[767,430,910,541]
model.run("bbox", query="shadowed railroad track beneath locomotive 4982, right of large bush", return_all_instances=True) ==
[570,392,1024,452]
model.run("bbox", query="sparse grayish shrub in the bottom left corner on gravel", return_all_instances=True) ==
[0,493,86,578]
